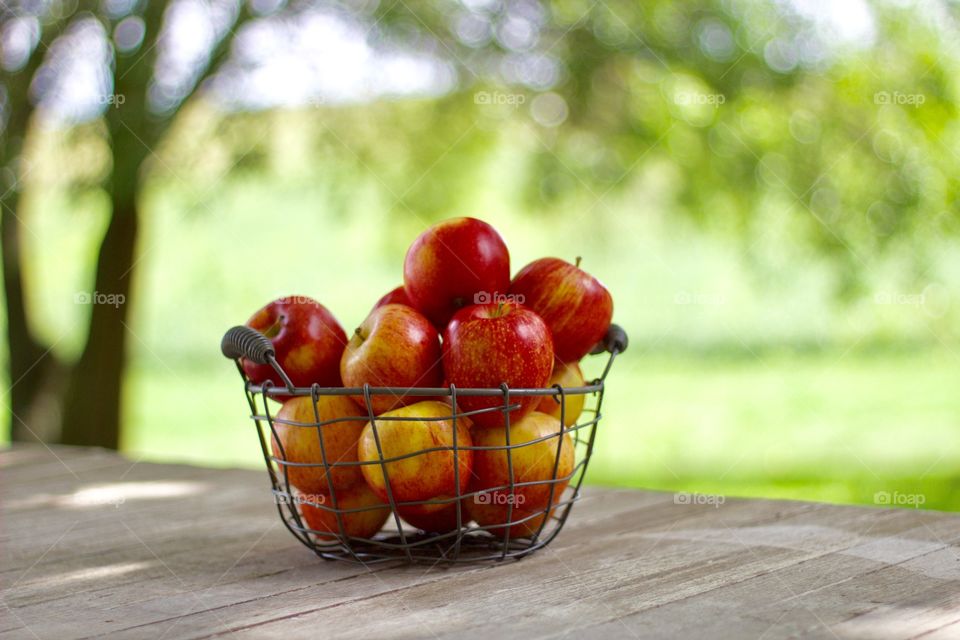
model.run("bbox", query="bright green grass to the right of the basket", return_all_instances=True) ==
[590,353,960,510]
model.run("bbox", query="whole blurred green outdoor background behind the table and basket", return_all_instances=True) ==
[0,0,960,510]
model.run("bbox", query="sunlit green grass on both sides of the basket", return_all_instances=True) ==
[123,345,960,510]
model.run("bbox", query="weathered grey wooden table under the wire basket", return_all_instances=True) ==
[0,446,960,640]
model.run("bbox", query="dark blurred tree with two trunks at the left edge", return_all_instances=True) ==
[0,0,250,448]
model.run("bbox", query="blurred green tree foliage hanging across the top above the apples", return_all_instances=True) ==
[20,0,960,288]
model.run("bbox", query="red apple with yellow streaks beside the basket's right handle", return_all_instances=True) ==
[510,258,613,362]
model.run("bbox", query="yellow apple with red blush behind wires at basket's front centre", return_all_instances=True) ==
[358,400,474,515]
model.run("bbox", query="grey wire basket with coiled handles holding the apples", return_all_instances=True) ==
[221,325,627,564]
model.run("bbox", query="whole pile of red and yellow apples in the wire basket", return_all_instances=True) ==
[243,218,613,538]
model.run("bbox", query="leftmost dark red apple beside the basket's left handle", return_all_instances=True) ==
[242,296,347,400]
